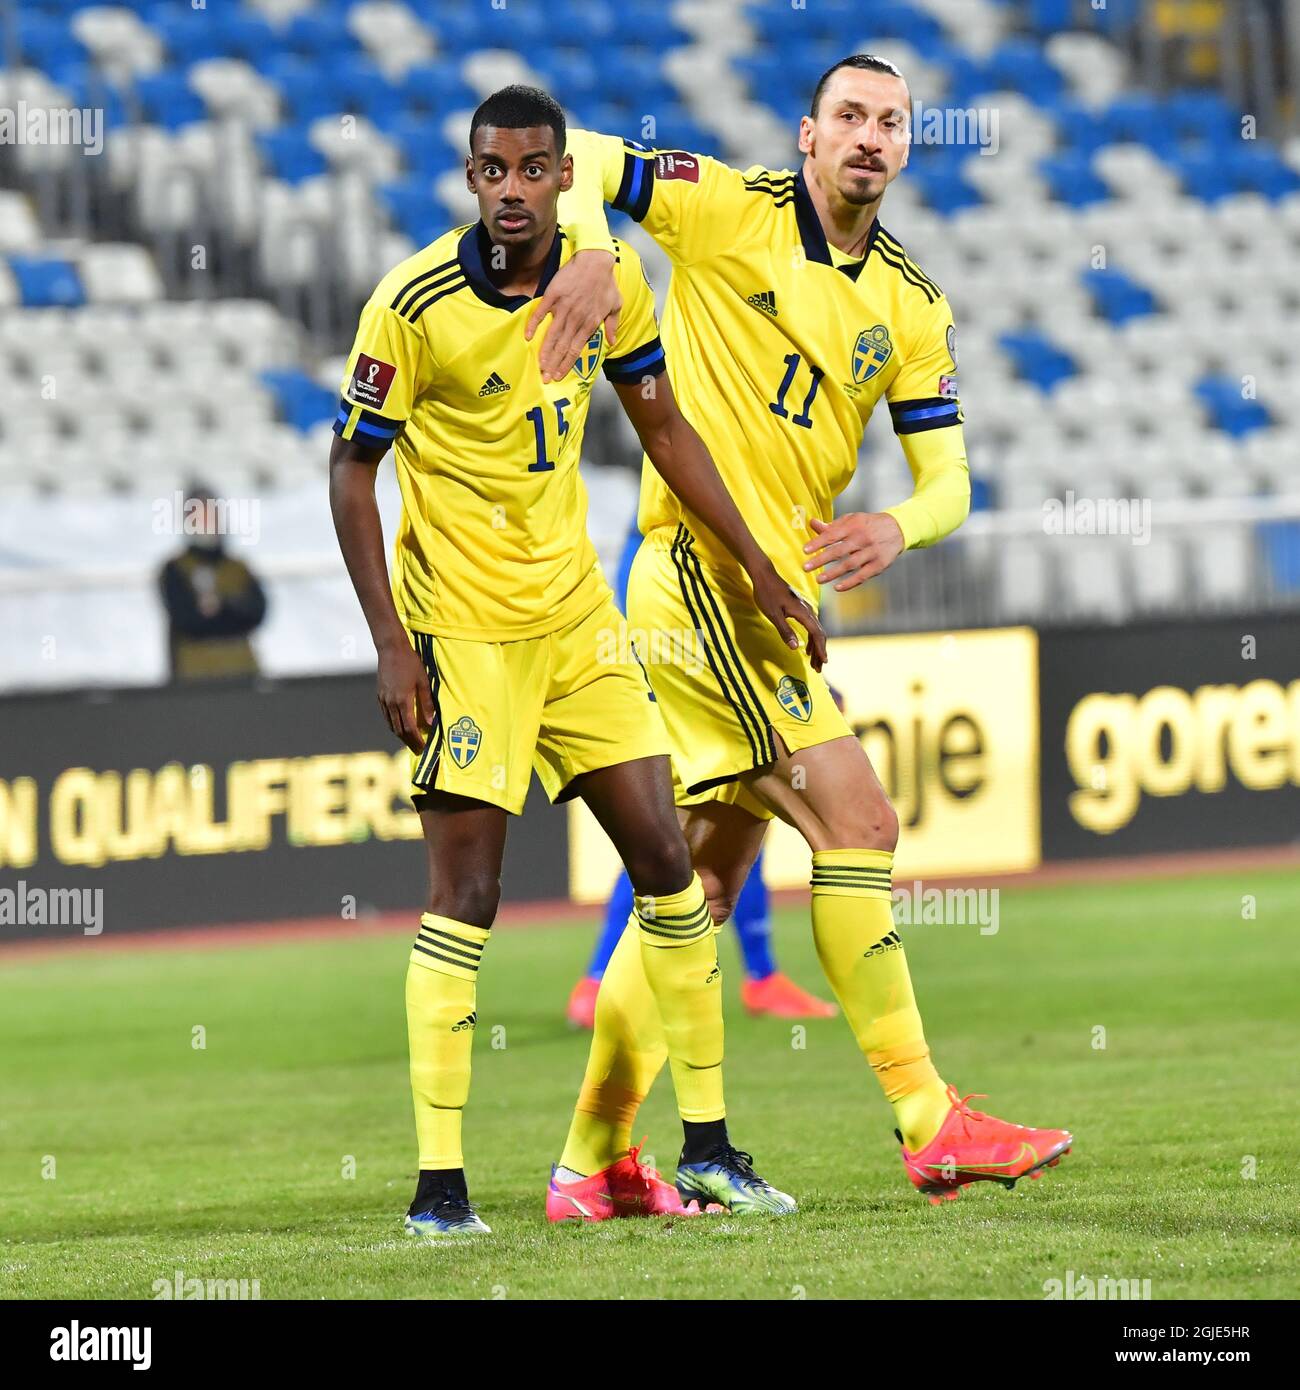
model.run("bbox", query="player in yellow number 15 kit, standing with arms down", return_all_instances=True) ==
[330,88,824,1236]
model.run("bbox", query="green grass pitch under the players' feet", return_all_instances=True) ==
[0,870,1300,1298]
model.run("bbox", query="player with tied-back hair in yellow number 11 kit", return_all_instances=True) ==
[528,54,1071,1201]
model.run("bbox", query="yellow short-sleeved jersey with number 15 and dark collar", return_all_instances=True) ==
[334,222,665,642]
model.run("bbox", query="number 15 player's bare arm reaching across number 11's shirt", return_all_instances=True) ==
[615,374,826,671]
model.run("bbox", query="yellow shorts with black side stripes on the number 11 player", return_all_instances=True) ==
[627,525,852,819]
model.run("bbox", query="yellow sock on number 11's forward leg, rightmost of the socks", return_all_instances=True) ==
[812,849,950,1152]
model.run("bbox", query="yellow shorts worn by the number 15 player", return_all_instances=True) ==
[410,595,669,816]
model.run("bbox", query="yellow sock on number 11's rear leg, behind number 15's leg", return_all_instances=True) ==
[560,917,667,1177]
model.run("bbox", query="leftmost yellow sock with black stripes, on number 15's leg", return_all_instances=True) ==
[406,912,488,1169]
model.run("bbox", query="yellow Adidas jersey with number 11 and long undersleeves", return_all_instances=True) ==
[560,131,969,602]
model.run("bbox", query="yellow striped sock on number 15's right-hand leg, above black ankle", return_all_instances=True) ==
[634,873,727,1123]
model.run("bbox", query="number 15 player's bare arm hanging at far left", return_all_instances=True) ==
[330,436,434,753]
